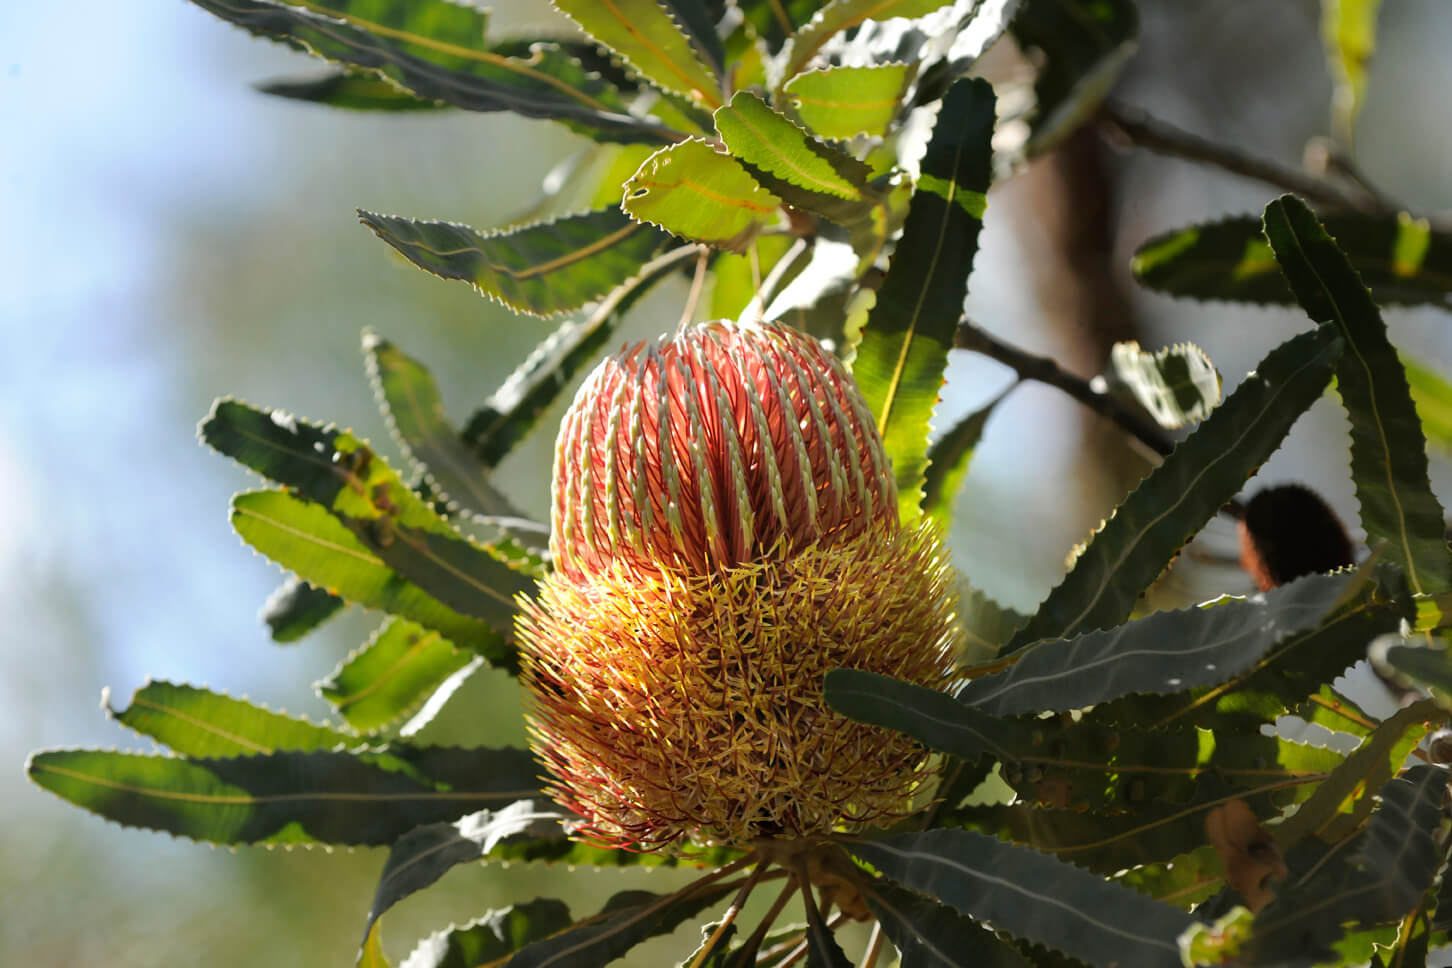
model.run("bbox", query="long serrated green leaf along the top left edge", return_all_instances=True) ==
[185,0,672,144]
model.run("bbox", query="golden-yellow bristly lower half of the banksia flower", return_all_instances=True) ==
[521,525,953,849]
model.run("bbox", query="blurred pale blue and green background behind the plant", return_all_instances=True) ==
[8,0,1452,968]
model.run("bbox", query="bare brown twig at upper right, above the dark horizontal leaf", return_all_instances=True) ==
[1099,103,1370,215]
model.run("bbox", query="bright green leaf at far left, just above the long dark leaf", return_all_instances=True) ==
[106,682,357,756]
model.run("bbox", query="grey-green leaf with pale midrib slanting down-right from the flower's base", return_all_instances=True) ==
[844,830,1194,968]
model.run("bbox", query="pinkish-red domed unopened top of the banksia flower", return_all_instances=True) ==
[550,321,897,576]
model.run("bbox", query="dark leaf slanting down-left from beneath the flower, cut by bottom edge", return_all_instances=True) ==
[508,882,736,968]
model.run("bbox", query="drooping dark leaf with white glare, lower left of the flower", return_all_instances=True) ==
[363,800,563,935]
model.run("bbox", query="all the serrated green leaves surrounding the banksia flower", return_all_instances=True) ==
[29,0,1452,968]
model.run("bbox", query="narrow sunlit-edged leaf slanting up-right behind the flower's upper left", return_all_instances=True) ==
[463,245,694,467]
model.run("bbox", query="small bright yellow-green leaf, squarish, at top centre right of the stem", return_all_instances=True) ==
[783,64,916,139]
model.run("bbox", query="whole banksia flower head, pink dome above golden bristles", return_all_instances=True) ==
[520,321,953,849]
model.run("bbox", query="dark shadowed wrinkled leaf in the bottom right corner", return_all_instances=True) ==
[1247,766,1448,965]
